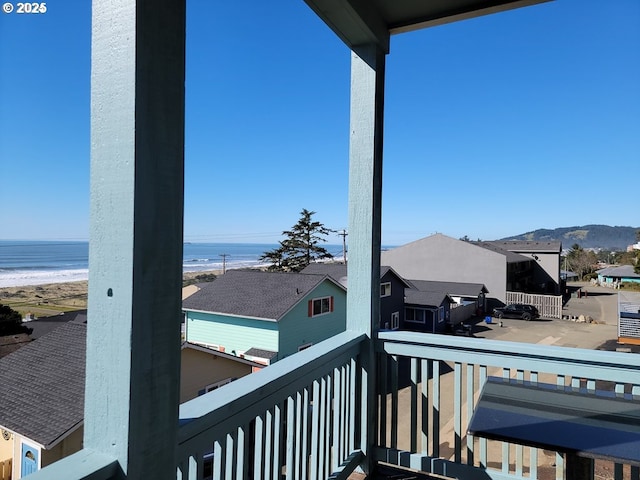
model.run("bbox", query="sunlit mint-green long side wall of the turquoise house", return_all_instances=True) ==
[186,312,276,354]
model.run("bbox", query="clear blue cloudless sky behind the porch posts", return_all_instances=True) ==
[0,0,640,245]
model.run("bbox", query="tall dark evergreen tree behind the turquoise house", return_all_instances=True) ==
[260,208,333,272]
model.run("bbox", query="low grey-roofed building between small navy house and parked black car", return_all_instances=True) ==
[409,280,489,325]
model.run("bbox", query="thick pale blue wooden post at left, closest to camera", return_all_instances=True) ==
[84,0,185,479]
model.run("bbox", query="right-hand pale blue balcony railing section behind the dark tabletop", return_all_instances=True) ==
[375,331,640,480]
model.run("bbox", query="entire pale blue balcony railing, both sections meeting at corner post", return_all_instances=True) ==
[27,331,640,480]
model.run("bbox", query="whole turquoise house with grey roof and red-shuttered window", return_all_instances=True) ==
[182,270,347,365]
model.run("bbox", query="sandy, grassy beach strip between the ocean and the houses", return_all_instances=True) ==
[0,270,222,317]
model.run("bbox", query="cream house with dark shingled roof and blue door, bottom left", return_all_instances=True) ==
[0,322,87,480]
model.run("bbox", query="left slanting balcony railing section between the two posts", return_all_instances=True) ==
[177,331,367,478]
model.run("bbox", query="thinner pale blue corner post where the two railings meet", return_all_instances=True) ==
[347,45,385,473]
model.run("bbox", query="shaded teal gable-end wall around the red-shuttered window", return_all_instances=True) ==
[278,282,347,360]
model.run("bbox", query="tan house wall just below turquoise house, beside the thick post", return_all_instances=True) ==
[180,342,263,403]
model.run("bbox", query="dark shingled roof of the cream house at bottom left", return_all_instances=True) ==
[0,322,87,449]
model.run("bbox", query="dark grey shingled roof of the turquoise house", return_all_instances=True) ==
[182,270,344,320]
